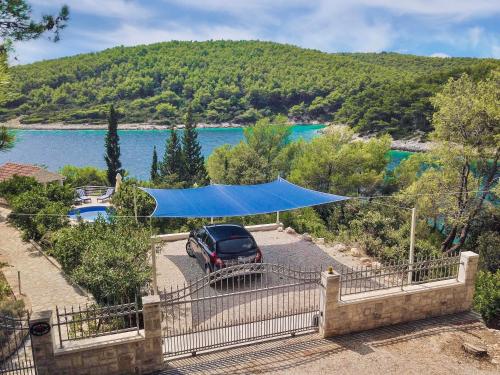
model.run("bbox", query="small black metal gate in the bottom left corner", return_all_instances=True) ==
[0,315,36,375]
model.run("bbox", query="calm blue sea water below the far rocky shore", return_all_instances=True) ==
[0,125,323,179]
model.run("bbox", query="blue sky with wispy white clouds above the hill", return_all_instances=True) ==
[12,0,500,64]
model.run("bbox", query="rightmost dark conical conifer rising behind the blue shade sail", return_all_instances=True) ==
[182,105,208,186]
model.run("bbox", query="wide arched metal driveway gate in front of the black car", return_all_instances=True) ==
[160,263,320,357]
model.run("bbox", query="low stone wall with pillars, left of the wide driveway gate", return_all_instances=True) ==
[30,296,163,375]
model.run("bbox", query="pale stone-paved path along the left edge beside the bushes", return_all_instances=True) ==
[0,207,89,311]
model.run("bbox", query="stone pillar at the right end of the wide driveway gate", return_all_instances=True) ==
[319,271,340,337]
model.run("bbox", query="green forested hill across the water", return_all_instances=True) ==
[0,41,500,136]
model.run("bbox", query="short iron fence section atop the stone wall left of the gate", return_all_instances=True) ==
[56,297,142,348]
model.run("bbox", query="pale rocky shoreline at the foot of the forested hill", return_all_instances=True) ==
[0,121,432,152]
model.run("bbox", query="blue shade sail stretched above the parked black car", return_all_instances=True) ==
[141,178,349,218]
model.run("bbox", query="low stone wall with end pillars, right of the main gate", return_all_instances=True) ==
[320,251,478,337]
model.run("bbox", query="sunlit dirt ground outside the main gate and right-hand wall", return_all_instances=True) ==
[161,313,500,375]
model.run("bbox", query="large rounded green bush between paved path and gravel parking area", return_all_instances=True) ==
[50,219,151,302]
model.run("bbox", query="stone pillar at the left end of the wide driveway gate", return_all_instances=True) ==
[142,295,163,373]
